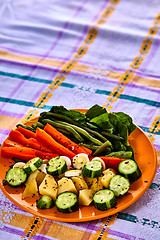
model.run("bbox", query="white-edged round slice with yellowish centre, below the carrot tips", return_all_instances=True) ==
[73,153,89,170]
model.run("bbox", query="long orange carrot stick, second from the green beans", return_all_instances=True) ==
[36,128,75,159]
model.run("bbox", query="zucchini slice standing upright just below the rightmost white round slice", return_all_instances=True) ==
[82,160,102,178]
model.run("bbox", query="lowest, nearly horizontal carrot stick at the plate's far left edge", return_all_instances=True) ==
[1,147,36,162]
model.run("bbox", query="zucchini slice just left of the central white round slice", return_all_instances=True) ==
[47,157,67,176]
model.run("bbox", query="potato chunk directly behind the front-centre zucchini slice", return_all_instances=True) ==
[58,177,77,194]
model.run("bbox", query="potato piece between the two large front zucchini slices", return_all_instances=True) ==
[79,189,93,206]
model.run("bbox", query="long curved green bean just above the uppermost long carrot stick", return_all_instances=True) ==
[42,119,84,142]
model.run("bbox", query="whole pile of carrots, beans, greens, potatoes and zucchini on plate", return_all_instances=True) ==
[1,105,141,213]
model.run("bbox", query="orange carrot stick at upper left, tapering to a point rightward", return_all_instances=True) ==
[9,130,51,152]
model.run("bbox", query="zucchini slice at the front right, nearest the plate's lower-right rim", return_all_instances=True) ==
[93,189,117,211]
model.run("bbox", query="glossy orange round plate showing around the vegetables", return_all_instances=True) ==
[0,109,157,222]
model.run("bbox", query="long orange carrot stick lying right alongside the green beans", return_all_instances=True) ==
[44,123,92,155]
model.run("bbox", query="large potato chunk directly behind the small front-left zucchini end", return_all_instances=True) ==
[39,174,57,200]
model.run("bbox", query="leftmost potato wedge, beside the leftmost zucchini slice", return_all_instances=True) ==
[22,178,39,199]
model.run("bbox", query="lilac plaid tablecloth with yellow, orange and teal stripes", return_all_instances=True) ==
[0,0,160,240]
